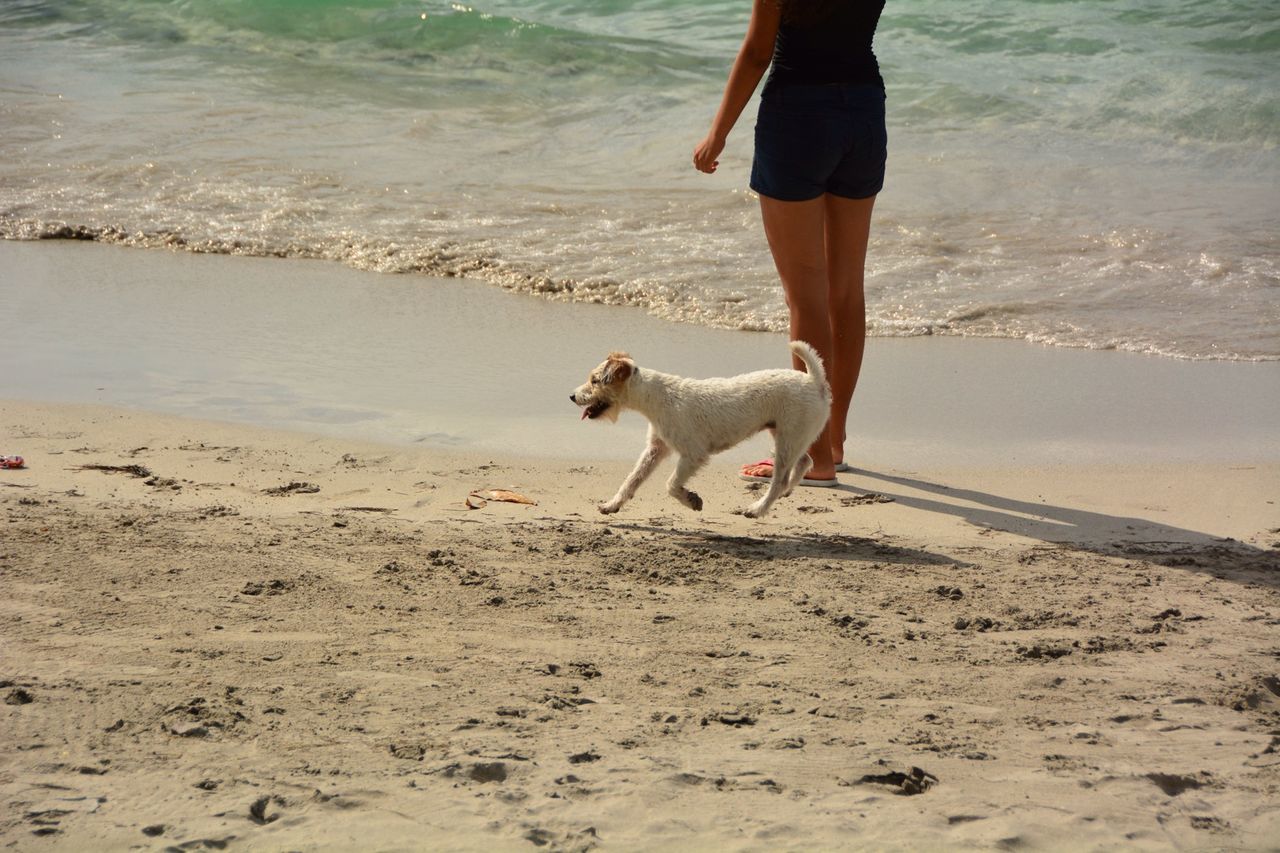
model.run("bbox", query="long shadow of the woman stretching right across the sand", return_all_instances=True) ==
[851,469,1280,587]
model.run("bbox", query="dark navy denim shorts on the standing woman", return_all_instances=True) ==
[751,83,888,201]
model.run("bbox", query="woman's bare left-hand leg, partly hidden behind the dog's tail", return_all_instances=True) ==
[760,196,839,480]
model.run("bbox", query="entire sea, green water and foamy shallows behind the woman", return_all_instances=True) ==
[0,0,1280,360]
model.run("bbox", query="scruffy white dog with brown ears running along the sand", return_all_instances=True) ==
[568,341,831,519]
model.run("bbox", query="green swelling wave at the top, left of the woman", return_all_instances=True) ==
[0,0,721,105]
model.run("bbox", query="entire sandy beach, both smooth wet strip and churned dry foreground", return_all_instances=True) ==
[0,245,1280,850]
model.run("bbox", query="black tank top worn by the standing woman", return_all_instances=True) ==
[764,0,884,90]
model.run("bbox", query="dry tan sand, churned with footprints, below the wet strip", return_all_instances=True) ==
[0,402,1280,850]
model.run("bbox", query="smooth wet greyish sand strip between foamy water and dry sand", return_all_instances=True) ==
[0,235,1280,467]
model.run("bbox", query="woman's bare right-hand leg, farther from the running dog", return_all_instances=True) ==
[824,193,876,464]
